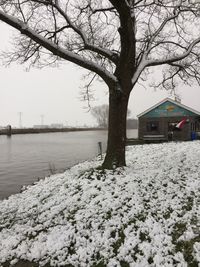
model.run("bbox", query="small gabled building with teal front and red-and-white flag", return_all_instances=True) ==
[138,98,200,141]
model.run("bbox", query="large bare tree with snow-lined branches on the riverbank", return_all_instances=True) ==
[0,0,200,168]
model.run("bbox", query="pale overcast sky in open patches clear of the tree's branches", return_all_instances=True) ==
[0,22,200,127]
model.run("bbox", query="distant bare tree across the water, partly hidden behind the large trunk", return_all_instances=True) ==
[91,104,131,128]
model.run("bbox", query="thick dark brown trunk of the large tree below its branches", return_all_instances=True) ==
[102,87,129,169]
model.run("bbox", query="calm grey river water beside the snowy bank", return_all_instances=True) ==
[0,130,137,199]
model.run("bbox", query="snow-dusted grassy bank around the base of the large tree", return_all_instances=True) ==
[0,141,200,267]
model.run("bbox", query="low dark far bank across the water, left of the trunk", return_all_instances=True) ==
[0,127,107,135]
